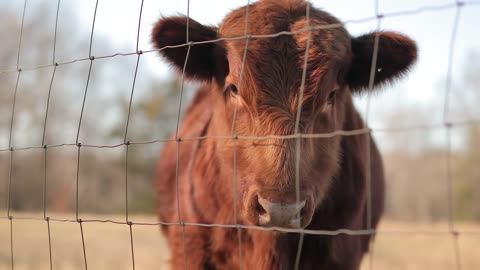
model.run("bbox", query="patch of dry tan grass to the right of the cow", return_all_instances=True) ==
[362,221,480,270]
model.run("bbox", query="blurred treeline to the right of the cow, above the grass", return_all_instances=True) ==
[384,52,480,221]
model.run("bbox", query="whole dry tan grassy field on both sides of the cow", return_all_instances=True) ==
[0,214,480,270]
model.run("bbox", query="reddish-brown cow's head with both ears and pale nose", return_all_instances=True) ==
[152,0,416,227]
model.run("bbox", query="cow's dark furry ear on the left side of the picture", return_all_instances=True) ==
[152,16,228,80]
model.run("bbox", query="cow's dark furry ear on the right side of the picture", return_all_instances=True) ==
[347,32,417,93]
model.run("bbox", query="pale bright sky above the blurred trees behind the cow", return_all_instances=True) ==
[1,0,480,152]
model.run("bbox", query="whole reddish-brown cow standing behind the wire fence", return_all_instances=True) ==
[152,0,417,269]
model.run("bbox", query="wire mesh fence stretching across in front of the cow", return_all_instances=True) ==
[0,0,480,269]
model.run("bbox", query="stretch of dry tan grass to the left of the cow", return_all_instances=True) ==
[0,215,169,270]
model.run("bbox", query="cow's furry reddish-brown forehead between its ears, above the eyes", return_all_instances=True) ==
[219,1,351,87]
